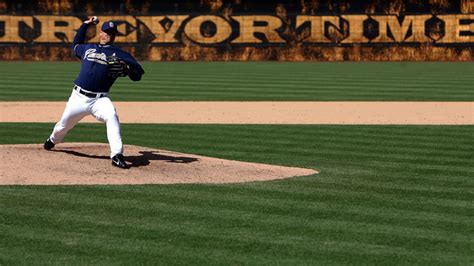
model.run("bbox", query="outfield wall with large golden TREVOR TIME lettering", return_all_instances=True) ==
[0,12,474,61]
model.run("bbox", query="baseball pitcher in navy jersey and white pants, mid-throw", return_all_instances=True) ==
[44,16,145,169]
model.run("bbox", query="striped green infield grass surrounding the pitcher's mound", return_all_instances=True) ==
[0,123,474,265]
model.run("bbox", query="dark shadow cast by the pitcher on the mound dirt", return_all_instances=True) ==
[53,150,198,167]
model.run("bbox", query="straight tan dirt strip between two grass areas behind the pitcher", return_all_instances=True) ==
[0,102,474,125]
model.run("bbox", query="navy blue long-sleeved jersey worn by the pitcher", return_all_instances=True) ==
[73,23,145,92]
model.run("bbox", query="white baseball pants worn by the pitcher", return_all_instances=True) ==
[49,89,123,158]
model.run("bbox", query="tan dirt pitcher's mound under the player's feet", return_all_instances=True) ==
[0,143,317,185]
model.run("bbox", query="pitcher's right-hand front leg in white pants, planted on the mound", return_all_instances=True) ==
[91,97,123,158]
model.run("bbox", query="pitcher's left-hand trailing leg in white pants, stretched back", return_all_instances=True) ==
[45,91,89,148]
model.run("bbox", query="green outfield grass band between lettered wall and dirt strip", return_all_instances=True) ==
[0,61,474,101]
